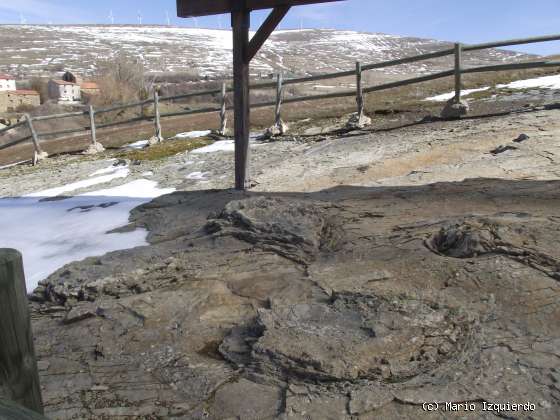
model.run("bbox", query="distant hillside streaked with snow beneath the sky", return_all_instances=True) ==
[0,25,528,77]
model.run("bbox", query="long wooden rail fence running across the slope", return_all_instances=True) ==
[0,35,560,163]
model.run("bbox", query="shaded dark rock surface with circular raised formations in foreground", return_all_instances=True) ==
[28,180,560,419]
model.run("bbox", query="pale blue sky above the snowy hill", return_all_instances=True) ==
[0,0,560,54]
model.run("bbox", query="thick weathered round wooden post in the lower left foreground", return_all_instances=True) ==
[0,248,43,414]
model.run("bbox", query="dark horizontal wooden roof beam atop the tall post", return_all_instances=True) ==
[177,0,341,17]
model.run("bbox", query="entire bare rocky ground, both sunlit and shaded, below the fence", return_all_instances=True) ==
[2,97,560,419]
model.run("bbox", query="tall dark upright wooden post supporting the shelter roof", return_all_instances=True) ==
[231,6,251,190]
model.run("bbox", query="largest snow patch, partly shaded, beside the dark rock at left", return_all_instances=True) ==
[0,179,174,292]
